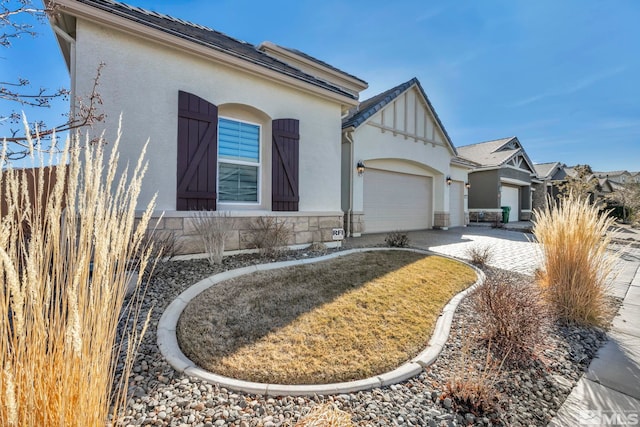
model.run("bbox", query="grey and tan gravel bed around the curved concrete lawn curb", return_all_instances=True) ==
[115,250,606,427]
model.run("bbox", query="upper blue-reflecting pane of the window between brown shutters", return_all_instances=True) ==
[218,118,260,163]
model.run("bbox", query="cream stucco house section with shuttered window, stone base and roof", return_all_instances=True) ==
[51,0,368,250]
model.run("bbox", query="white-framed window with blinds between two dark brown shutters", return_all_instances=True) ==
[218,117,261,204]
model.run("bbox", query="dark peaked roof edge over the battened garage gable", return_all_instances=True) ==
[342,77,456,152]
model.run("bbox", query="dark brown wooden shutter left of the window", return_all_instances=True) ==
[176,91,218,211]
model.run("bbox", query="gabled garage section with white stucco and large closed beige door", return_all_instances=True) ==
[342,78,472,236]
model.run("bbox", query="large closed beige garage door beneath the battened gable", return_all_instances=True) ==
[364,169,433,233]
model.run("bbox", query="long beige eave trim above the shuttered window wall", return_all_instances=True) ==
[51,0,358,108]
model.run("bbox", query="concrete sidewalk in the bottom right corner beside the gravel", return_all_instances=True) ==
[549,248,640,427]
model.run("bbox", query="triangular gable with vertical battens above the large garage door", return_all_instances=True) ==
[365,85,455,154]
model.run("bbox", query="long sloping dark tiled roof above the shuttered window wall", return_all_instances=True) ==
[72,0,357,99]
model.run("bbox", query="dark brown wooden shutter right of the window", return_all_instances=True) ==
[271,119,300,211]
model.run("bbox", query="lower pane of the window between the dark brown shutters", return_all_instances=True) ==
[218,163,258,202]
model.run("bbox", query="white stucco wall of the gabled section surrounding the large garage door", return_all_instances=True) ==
[343,84,467,234]
